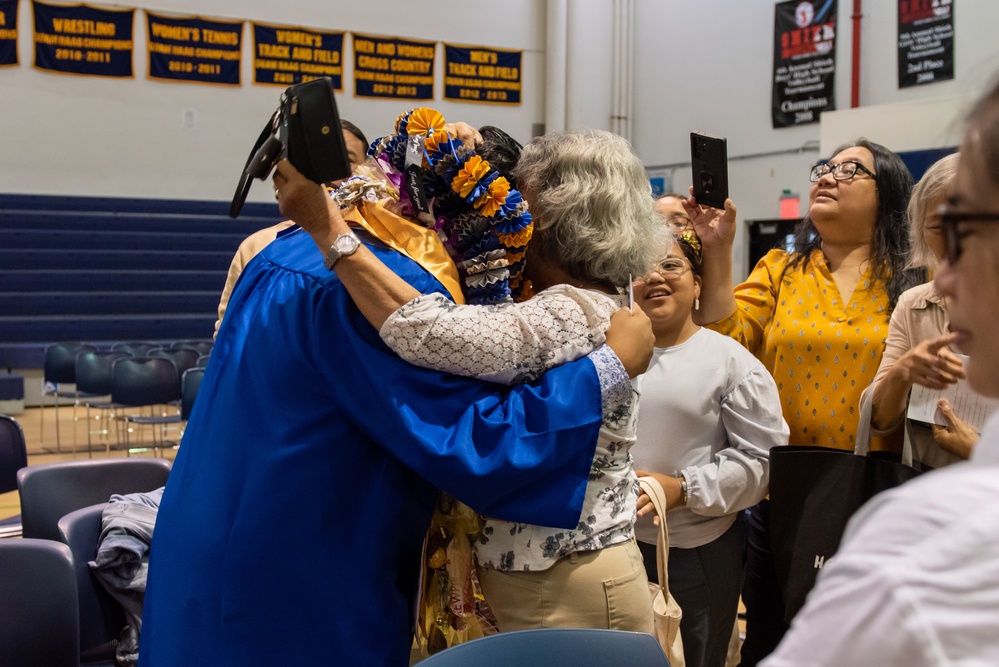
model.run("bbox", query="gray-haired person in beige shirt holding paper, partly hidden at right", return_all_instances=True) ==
[861,153,978,468]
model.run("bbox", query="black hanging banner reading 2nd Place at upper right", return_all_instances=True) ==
[898,0,954,88]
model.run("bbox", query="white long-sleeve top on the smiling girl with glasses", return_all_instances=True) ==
[632,329,789,549]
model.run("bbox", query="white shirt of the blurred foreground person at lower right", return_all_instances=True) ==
[763,415,999,667]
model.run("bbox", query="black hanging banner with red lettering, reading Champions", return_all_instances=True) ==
[773,0,836,128]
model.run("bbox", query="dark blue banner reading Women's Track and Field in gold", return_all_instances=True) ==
[252,23,344,91]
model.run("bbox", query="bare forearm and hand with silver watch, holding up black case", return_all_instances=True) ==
[307,199,420,330]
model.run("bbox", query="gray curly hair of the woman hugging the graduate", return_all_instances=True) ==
[513,130,672,287]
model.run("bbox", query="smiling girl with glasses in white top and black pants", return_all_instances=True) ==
[631,231,788,667]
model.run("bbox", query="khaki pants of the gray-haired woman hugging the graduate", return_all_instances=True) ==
[478,540,653,634]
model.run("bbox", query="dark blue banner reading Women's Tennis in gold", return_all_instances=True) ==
[146,11,243,86]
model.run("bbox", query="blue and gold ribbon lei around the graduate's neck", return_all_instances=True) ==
[335,107,534,304]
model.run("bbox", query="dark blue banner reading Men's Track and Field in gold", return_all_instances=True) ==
[444,44,524,104]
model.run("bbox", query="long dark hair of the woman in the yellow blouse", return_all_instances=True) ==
[784,138,927,311]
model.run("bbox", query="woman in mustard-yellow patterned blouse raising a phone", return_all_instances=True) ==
[694,139,925,667]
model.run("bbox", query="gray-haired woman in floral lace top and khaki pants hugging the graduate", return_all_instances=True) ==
[275,125,667,632]
